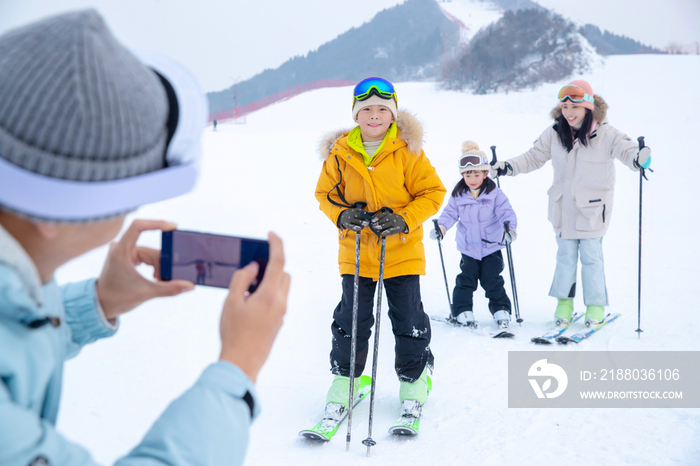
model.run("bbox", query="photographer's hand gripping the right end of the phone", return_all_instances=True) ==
[220,233,290,382]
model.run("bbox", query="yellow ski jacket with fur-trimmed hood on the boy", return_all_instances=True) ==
[316,111,446,280]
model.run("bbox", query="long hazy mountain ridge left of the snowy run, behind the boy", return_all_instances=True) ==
[207,0,459,113]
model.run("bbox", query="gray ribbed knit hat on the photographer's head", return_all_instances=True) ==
[0,10,169,182]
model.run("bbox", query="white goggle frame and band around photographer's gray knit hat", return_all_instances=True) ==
[0,51,207,221]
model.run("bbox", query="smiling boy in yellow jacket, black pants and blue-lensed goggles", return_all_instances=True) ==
[316,78,446,420]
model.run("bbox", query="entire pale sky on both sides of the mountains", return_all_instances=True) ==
[0,0,700,91]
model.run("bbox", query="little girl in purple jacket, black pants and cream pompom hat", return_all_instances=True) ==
[430,141,518,329]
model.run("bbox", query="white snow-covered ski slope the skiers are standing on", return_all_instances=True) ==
[58,55,700,466]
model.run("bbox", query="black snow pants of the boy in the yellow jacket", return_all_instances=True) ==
[331,275,433,382]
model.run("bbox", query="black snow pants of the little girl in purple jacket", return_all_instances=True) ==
[452,251,510,316]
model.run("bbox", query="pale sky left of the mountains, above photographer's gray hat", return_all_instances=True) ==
[0,0,403,92]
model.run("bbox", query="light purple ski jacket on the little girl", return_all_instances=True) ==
[438,188,518,260]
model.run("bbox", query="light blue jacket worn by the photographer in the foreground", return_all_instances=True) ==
[0,227,258,466]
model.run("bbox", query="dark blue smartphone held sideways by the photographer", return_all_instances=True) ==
[160,230,270,292]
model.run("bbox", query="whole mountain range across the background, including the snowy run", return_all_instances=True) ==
[207,0,649,120]
